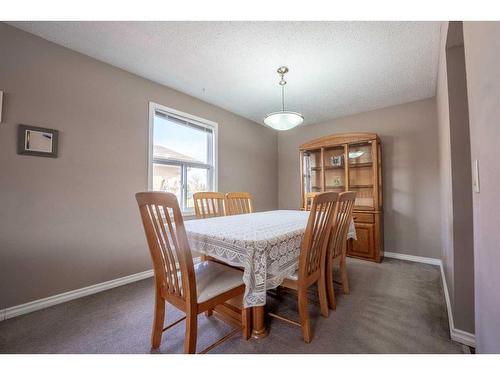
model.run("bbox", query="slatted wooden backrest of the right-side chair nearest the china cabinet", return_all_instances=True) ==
[328,191,356,258]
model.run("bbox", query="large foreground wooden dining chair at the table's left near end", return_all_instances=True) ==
[135,192,250,353]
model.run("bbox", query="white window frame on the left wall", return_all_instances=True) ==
[148,102,219,216]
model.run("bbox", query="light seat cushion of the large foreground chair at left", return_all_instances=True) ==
[194,261,243,303]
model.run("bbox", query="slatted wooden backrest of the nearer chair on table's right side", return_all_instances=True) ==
[299,192,338,279]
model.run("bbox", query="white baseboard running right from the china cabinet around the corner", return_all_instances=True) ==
[384,252,476,348]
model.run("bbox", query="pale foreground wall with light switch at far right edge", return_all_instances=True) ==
[464,22,500,353]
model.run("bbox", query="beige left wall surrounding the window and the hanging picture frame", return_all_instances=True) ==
[0,23,278,308]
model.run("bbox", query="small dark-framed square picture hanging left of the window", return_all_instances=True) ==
[17,125,59,158]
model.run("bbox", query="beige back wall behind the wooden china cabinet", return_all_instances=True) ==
[278,98,441,258]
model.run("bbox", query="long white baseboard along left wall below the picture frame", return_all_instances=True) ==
[0,270,153,321]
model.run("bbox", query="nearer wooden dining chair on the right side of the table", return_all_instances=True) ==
[269,192,338,343]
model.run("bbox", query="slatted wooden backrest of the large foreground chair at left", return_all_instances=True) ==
[135,192,197,303]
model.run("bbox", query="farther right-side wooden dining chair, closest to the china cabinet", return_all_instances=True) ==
[326,191,356,310]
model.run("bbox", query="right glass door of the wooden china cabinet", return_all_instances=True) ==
[348,143,375,209]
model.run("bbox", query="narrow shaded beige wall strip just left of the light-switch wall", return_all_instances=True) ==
[436,22,474,333]
